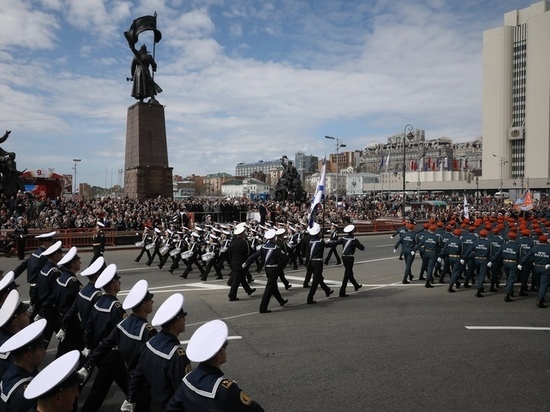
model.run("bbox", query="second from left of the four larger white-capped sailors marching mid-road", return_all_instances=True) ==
[245,229,288,313]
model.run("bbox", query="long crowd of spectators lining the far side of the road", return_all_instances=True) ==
[0,193,550,231]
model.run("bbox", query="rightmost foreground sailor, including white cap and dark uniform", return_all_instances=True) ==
[165,320,264,412]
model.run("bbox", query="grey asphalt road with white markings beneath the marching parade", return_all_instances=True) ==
[8,235,550,412]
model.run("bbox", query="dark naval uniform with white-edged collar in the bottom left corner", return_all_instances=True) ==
[0,364,38,412]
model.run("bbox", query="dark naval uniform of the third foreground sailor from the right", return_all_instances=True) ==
[84,313,157,412]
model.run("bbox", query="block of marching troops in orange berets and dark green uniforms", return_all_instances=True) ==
[391,214,550,308]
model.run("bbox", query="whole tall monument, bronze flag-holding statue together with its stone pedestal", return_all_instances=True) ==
[124,13,173,199]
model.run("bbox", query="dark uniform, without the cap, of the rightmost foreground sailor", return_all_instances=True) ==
[165,363,264,412]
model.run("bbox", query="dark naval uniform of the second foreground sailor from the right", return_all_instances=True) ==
[128,330,192,412]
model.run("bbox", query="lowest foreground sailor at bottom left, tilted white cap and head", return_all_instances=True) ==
[24,350,81,412]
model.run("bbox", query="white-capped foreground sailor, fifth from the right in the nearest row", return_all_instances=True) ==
[59,256,105,350]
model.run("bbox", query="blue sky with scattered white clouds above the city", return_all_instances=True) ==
[0,0,536,187]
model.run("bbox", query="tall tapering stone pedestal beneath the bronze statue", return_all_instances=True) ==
[124,102,173,199]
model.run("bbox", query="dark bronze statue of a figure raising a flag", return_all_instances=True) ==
[124,12,162,103]
